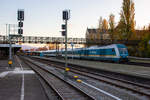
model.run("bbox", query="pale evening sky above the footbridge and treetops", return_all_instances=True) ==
[0,0,150,38]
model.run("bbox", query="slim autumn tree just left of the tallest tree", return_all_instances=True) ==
[109,14,115,41]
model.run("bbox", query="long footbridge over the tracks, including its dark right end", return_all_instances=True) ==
[0,36,140,46]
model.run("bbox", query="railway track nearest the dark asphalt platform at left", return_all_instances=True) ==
[21,57,95,100]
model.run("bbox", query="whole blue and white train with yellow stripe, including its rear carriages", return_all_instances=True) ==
[27,44,128,62]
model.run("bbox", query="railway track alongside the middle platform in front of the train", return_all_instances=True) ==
[30,56,150,98]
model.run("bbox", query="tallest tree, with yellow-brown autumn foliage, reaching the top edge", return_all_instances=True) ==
[117,0,135,41]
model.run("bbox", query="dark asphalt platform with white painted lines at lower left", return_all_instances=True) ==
[0,56,48,100]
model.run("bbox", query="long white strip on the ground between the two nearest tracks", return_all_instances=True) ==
[82,81,122,100]
